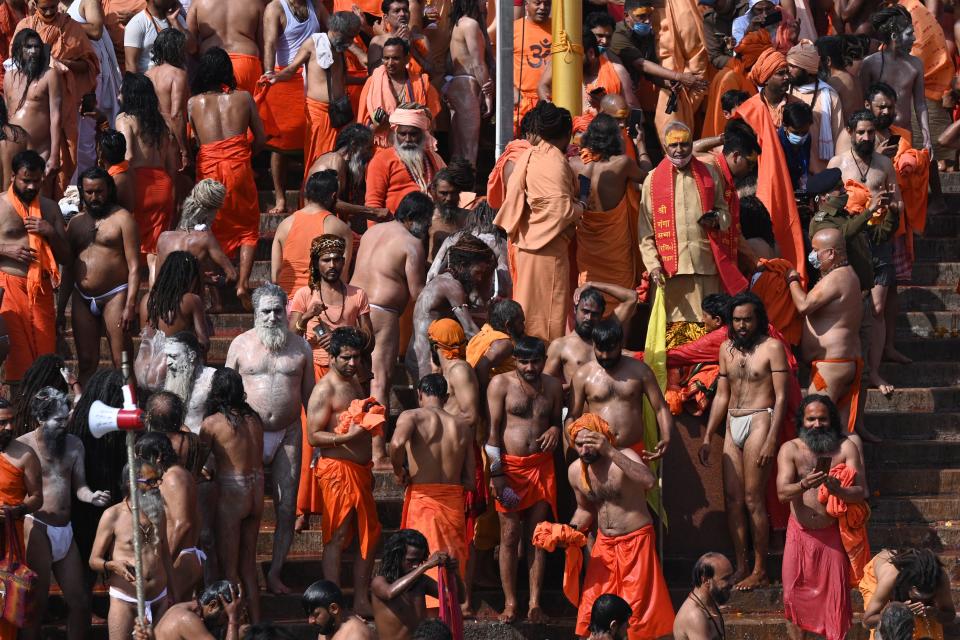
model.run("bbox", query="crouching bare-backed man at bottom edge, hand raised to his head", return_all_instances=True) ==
[153,580,244,640]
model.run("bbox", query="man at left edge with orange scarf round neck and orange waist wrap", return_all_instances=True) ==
[0,151,70,383]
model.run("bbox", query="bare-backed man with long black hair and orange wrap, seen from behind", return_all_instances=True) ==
[188,47,265,305]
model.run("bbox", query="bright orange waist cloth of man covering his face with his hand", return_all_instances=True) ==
[577,524,673,640]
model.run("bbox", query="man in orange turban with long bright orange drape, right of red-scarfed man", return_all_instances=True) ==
[737,49,807,278]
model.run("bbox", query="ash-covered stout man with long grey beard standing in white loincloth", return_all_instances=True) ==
[226,283,314,594]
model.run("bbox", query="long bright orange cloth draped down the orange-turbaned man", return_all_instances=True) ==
[737,93,807,279]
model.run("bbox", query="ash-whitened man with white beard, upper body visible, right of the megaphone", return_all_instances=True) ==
[163,331,218,433]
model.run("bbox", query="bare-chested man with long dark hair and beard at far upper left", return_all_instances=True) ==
[3,29,66,190]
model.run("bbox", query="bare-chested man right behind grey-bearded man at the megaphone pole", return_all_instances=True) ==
[136,432,202,602]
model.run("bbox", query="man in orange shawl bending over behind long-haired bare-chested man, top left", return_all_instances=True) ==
[14,0,100,196]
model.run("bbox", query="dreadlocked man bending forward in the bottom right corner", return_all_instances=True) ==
[860,549,957,640]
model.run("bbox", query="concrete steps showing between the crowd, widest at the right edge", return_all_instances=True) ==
[47,169,960,640]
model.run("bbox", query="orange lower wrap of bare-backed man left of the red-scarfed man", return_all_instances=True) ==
[577,191,639,302]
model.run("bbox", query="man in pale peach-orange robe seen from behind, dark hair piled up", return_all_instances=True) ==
[494,103,583,342]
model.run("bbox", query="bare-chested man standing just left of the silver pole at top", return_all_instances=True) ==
[443,2,494,166]
